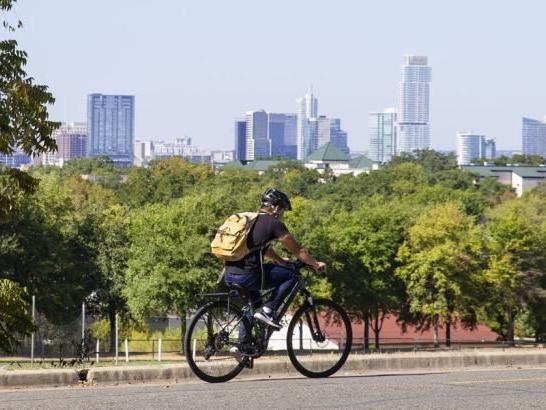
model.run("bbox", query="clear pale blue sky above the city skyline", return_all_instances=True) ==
[7,0,546,150]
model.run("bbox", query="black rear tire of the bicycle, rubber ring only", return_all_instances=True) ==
[184,301,250,383]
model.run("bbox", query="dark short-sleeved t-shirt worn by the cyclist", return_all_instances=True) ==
[226,214,288,274]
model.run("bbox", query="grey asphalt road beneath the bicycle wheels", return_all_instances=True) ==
[0,369,546,409]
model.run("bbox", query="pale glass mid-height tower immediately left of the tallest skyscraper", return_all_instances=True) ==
[368,108,397,163]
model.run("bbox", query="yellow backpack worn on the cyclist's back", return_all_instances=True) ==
[210,212,260,261]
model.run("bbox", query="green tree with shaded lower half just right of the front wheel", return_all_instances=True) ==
[327,197,408,350]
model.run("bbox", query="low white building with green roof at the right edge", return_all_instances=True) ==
[461,165,546,196]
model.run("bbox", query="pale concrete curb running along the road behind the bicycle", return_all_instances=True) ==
[0,350,546,389]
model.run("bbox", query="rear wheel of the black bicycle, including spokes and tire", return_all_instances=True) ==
[184,301,250,383]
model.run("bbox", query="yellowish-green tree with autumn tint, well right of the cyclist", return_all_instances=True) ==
[396,202,481,345]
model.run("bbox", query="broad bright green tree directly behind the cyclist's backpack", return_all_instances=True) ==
[123,188,244,350]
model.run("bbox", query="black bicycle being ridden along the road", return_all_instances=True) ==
[184,261,352,383]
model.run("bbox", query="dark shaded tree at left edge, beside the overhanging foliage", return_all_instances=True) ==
[0,175,93,323]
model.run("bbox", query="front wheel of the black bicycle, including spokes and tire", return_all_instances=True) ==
[286,299,353,377]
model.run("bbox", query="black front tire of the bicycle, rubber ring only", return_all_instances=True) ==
[286,299,353,378]
